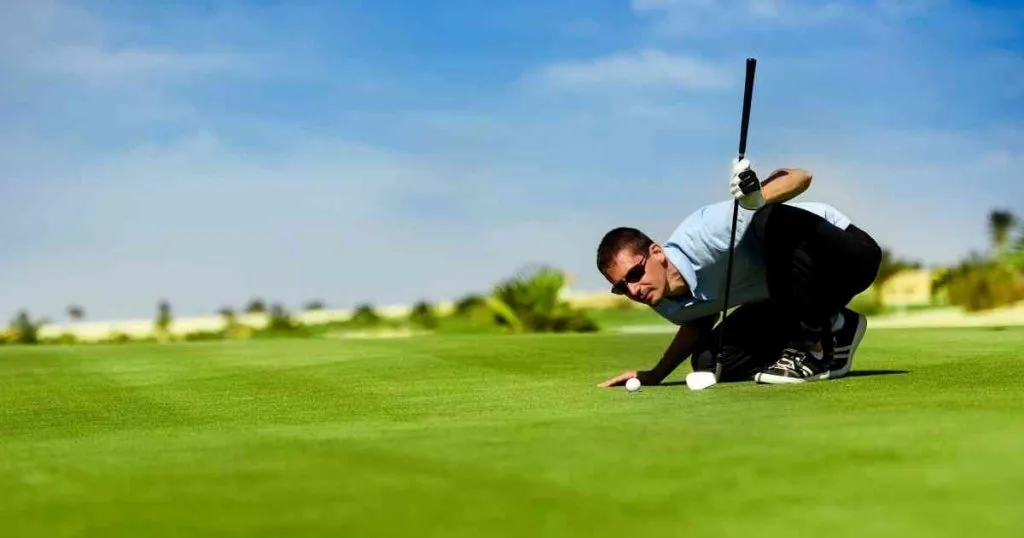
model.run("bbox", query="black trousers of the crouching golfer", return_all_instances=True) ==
[692,204,882,381]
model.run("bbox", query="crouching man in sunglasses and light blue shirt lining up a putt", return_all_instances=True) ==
[597,159,881,386]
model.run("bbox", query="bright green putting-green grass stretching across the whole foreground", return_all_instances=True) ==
[0,330,1024,538]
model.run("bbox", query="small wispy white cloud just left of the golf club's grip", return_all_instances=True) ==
[529,49,732,89]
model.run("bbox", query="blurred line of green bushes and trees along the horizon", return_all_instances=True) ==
[0,209,1024,343]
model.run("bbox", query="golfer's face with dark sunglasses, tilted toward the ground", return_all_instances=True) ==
[604,244,668,305]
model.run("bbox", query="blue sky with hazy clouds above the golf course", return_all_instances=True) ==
[0,0,1024,320]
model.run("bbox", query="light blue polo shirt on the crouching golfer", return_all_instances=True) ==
[652,200,851,324]
